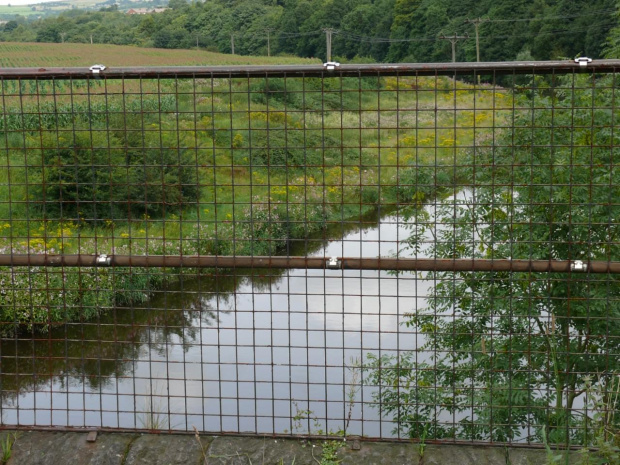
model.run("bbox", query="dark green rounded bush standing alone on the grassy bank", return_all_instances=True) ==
[30,131,198,220]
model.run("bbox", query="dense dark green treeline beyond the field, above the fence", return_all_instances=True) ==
[0,0,618,62]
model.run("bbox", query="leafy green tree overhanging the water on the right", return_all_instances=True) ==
[367,75,620,448]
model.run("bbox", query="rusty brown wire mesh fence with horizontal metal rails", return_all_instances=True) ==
[0,61,620,445]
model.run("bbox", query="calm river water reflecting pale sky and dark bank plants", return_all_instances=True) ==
[1,206,430,436]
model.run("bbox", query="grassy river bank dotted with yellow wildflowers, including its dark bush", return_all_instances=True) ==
[0,73,512,332]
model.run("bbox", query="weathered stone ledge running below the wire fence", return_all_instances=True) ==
[0,431,579,465]
